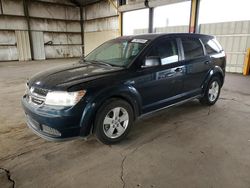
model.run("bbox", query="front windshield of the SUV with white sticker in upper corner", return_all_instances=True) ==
[84,39,147,67]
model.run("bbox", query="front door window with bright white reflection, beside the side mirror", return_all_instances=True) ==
[148,39,179,65]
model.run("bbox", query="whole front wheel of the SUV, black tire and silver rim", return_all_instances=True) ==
[94,99,134,145]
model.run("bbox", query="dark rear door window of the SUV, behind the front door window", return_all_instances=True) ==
[181,38,204,60]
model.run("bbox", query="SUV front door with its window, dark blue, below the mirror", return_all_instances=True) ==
[135,38,185,113]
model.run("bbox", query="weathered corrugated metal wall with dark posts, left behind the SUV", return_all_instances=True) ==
[0,0,119,61]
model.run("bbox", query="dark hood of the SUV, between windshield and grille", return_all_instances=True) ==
[29,62,124,89]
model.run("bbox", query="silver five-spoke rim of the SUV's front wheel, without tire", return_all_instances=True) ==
[103,107,129,138]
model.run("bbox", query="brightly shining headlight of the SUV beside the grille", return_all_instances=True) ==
[45,90,86,106]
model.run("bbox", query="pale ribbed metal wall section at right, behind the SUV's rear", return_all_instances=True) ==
[200,21,250,73]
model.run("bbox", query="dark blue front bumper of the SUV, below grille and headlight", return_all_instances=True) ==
[22,96,83,141]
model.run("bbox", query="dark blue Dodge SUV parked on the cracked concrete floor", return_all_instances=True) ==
[22,33,226,144]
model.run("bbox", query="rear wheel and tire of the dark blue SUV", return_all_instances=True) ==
[200,76,222,106]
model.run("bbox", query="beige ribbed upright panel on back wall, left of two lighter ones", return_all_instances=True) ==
[16,31,31,61]
